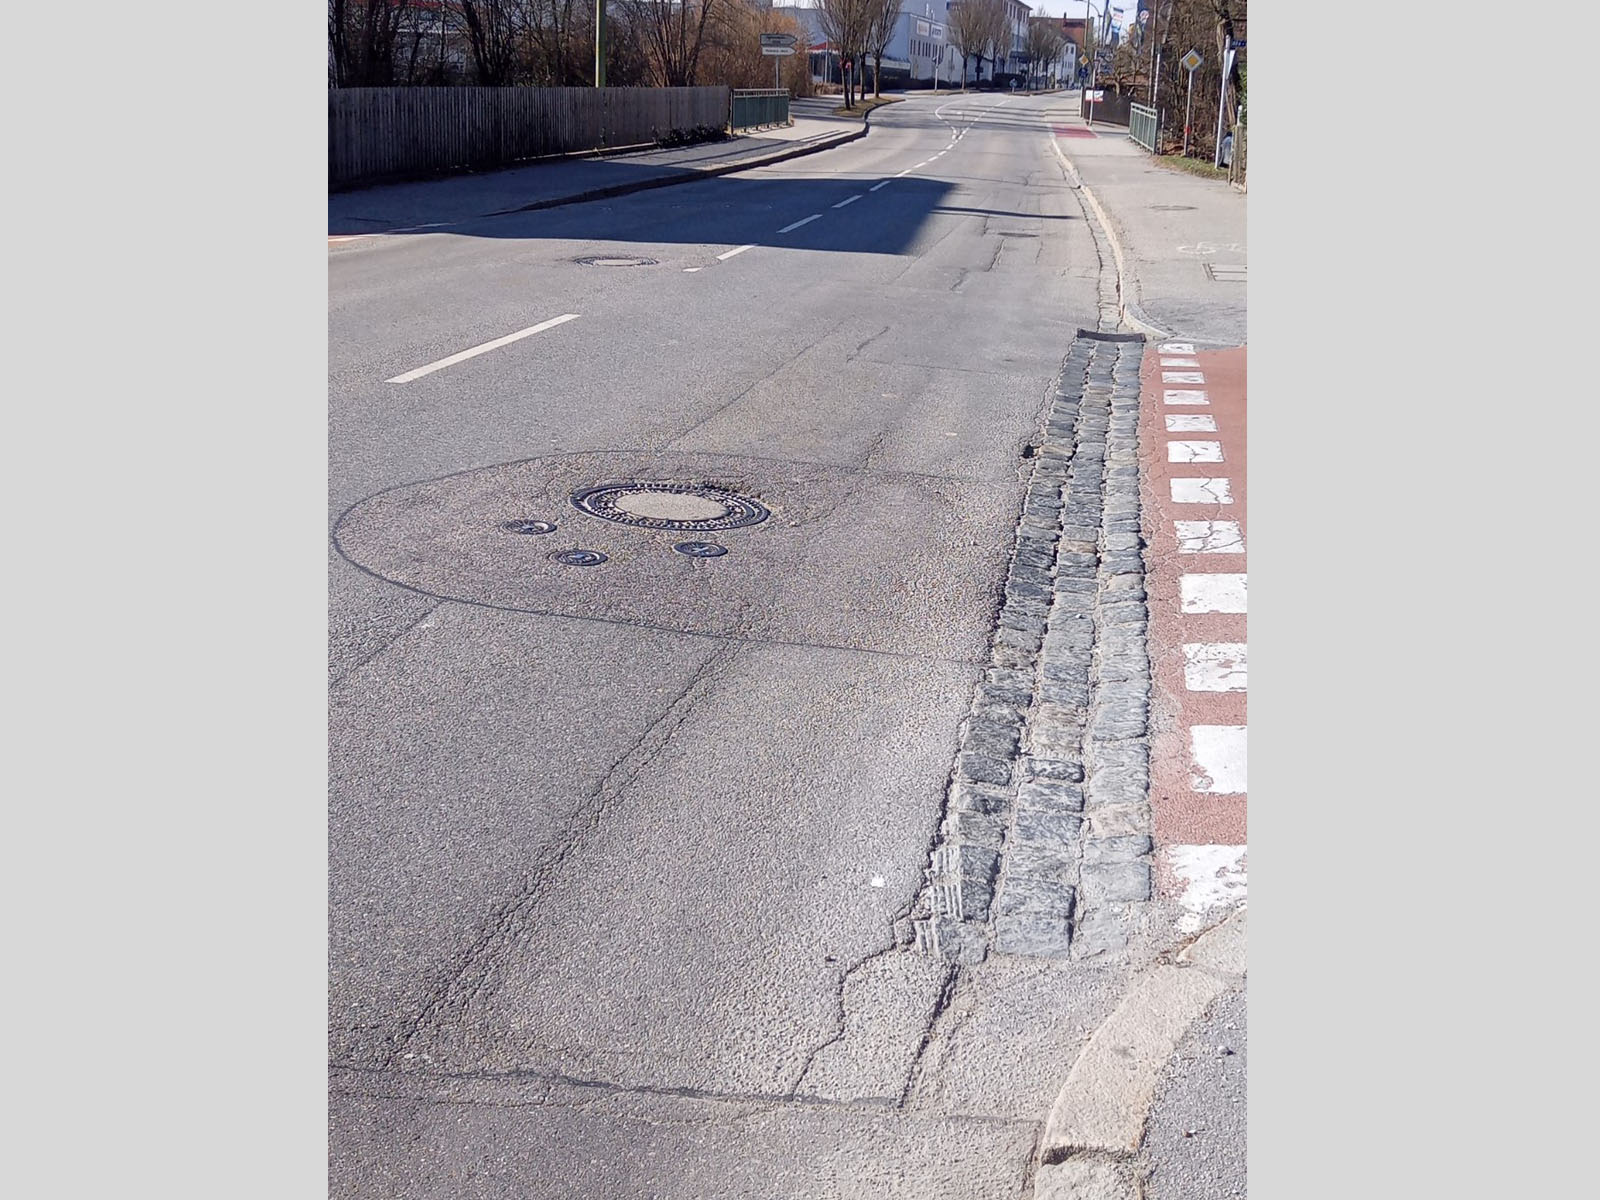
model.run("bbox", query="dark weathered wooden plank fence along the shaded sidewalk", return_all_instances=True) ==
[337,88,730,190]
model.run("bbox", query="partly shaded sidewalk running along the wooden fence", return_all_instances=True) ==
[328,117,867,240]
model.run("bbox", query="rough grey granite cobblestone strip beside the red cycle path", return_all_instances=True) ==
[910,330,1150,963]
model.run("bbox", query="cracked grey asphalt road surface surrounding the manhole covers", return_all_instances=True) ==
[328,96,1117,1200]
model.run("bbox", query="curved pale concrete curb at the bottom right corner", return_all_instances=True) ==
[1035,907,1246,1197]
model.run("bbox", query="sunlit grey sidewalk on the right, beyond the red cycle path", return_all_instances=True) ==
[1054,115,1248,347]
